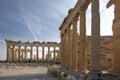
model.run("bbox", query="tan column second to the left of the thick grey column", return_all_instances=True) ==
[72,18,78,70]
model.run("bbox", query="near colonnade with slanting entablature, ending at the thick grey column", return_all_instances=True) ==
[60,0,100,73]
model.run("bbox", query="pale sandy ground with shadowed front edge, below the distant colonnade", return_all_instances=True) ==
[0,63,57,80]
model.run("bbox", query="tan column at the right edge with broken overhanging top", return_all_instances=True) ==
[107,0,120,73]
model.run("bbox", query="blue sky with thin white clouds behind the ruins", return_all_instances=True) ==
[0,0,114,60]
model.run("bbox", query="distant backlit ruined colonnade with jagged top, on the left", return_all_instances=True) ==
[5,40,60,62]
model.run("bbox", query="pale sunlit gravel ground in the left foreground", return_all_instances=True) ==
[0,67,57,80]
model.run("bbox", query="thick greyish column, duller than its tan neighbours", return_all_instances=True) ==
[90,0,100,73]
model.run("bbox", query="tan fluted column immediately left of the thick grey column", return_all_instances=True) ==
[79,8,86,72]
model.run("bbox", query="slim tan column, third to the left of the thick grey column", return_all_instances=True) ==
[68,25,72,69]
